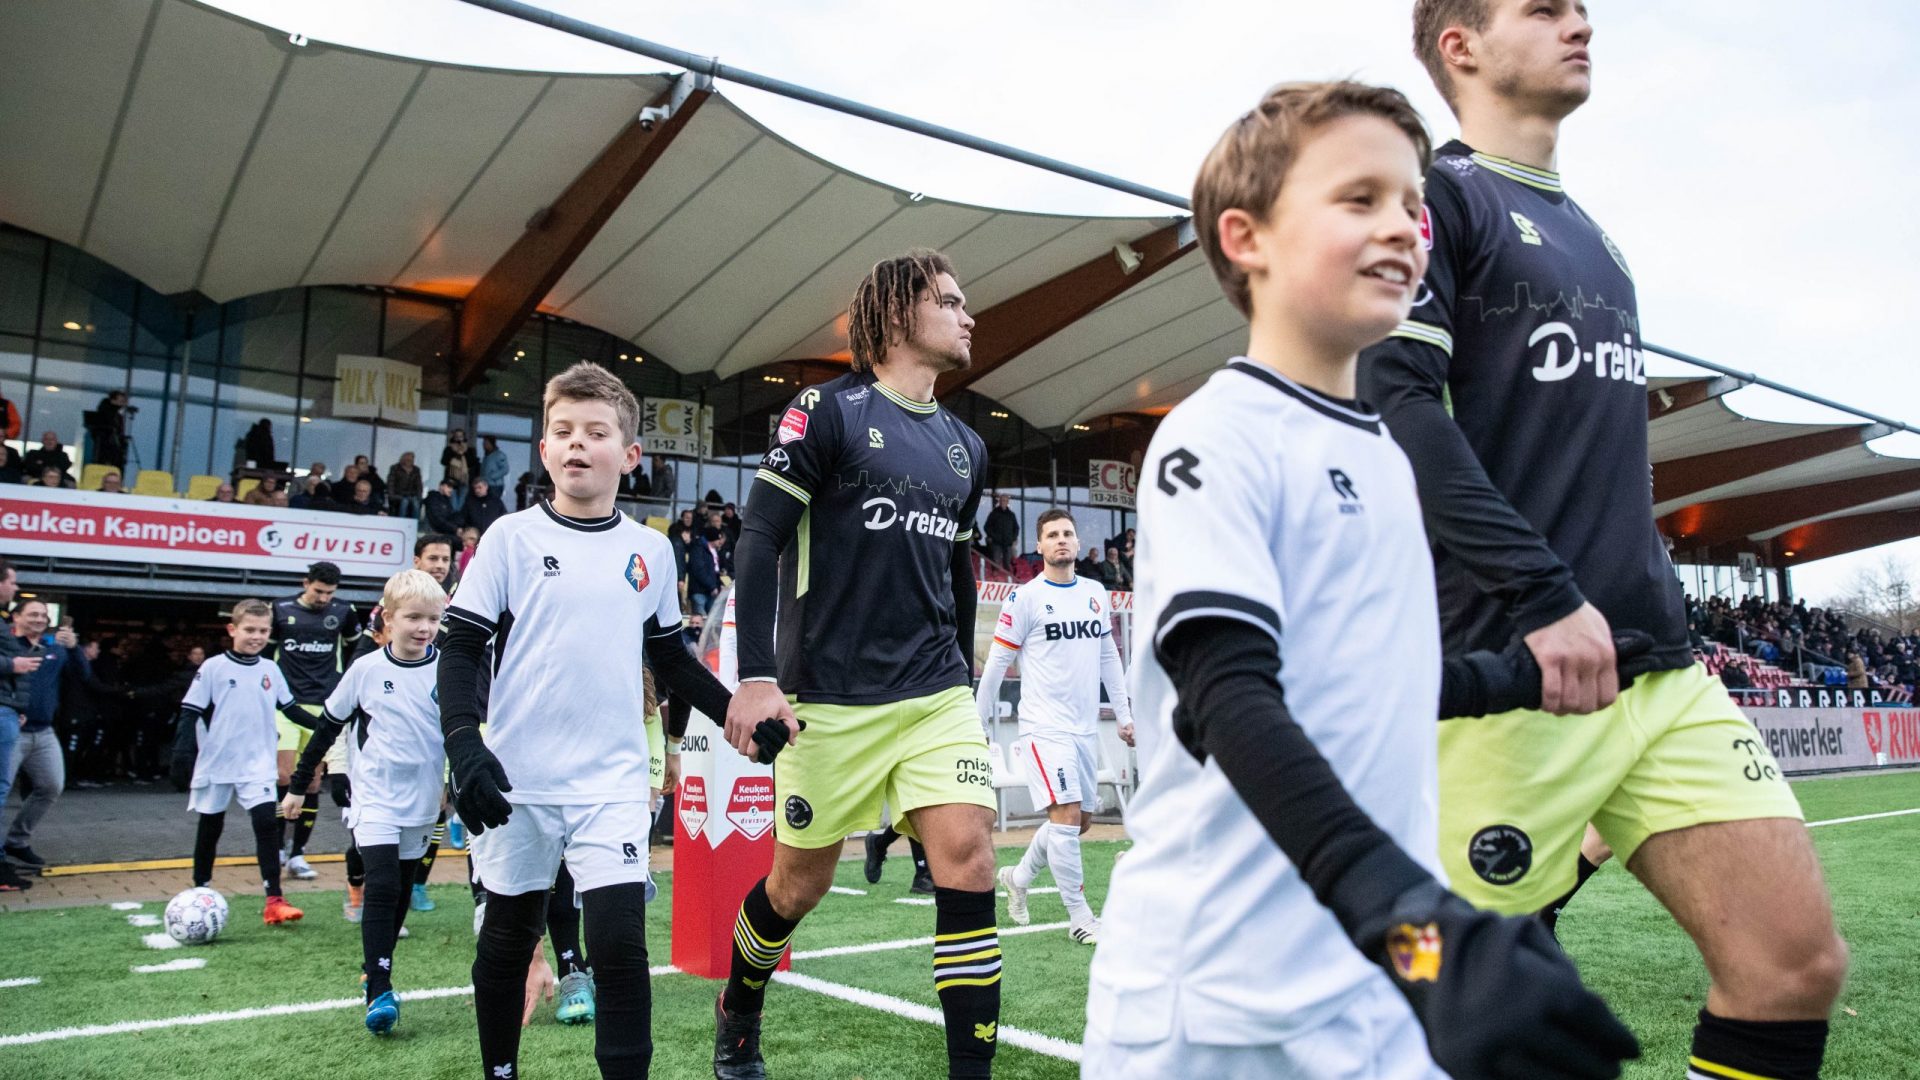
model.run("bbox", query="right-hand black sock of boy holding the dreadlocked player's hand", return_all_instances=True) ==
[568,882,653,1076]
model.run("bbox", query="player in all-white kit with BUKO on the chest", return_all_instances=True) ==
[975,507,1133,945]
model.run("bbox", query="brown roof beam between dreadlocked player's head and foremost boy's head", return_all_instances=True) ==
[933,221,1196,398]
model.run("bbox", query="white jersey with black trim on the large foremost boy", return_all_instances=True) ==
[1089,359,1444,1045]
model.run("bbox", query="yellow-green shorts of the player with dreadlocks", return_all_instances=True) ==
[774,686,996,847]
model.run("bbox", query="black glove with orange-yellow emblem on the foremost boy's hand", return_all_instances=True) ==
[1354,880,1640,1080]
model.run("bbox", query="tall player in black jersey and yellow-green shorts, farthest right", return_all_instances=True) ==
[1361,0,1847,1080]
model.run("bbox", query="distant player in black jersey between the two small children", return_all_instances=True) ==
[273,563,361,882]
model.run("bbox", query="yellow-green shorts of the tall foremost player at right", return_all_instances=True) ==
[1440,663,1803,915]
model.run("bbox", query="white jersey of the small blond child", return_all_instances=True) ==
[326,646,449,826]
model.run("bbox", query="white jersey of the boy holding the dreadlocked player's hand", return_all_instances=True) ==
[447,502,685,805]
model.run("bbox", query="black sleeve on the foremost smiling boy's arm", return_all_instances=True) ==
[1160,617,1432,936]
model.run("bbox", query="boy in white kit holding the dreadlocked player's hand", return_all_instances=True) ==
[440,361,730,1076]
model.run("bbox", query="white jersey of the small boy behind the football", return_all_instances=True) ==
[180,650,294,788]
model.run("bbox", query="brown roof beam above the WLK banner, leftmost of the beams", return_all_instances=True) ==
[453,75,712,390]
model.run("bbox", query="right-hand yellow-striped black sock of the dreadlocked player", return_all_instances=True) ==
[933,886,1000,1080]
